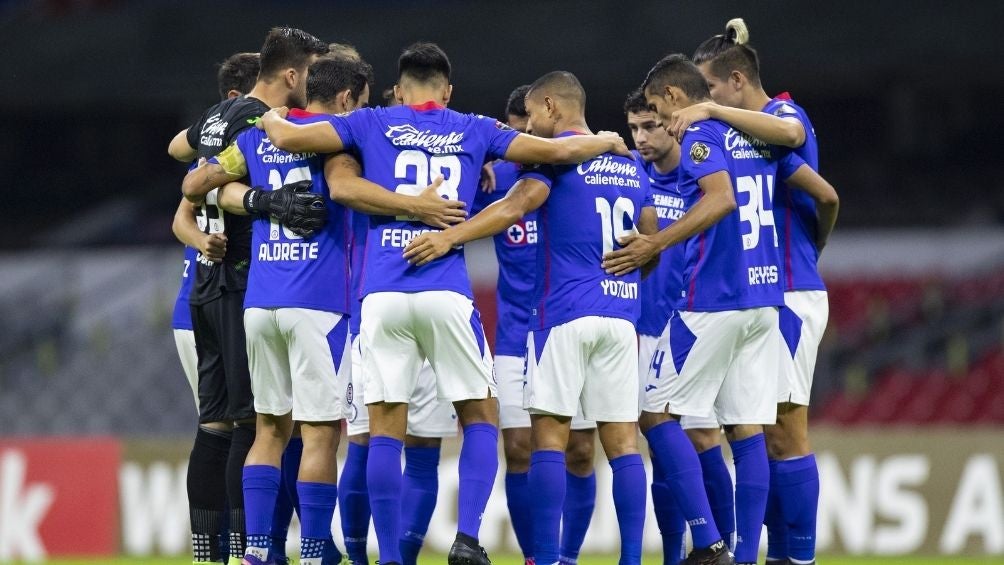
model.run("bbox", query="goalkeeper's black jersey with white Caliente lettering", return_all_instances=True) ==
[188,96,269,305]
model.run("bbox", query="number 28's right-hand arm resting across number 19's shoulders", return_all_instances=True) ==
[505,131,631,165]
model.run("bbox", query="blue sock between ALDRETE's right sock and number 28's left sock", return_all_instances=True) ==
[338,442,369,563]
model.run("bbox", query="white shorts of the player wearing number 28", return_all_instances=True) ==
[359,290,498,403]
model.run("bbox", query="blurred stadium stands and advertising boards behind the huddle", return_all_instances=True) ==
[0,0,1004,563]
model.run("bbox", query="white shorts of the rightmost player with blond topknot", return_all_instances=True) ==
[777,290,829,406]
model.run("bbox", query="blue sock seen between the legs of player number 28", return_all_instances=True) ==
[401,448,440,565]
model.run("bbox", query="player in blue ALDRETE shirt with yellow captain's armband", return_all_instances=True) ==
[184,57,469,564]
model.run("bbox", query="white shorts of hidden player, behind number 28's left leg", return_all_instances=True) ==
[346,335,457,438]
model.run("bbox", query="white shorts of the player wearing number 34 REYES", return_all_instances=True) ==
[643,307,781,428]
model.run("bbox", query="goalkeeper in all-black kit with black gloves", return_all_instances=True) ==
[170,28,327,562]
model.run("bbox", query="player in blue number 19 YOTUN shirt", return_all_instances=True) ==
[406,71,657,564]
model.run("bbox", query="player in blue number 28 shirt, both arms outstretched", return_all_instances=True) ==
[262,43,628,565]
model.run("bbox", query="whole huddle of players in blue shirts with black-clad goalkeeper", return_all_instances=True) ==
[169,16,838,565]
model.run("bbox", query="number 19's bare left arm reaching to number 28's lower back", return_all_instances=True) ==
[404,178,550,266]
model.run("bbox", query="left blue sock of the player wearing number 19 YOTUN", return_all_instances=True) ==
[527,451,567,564]
